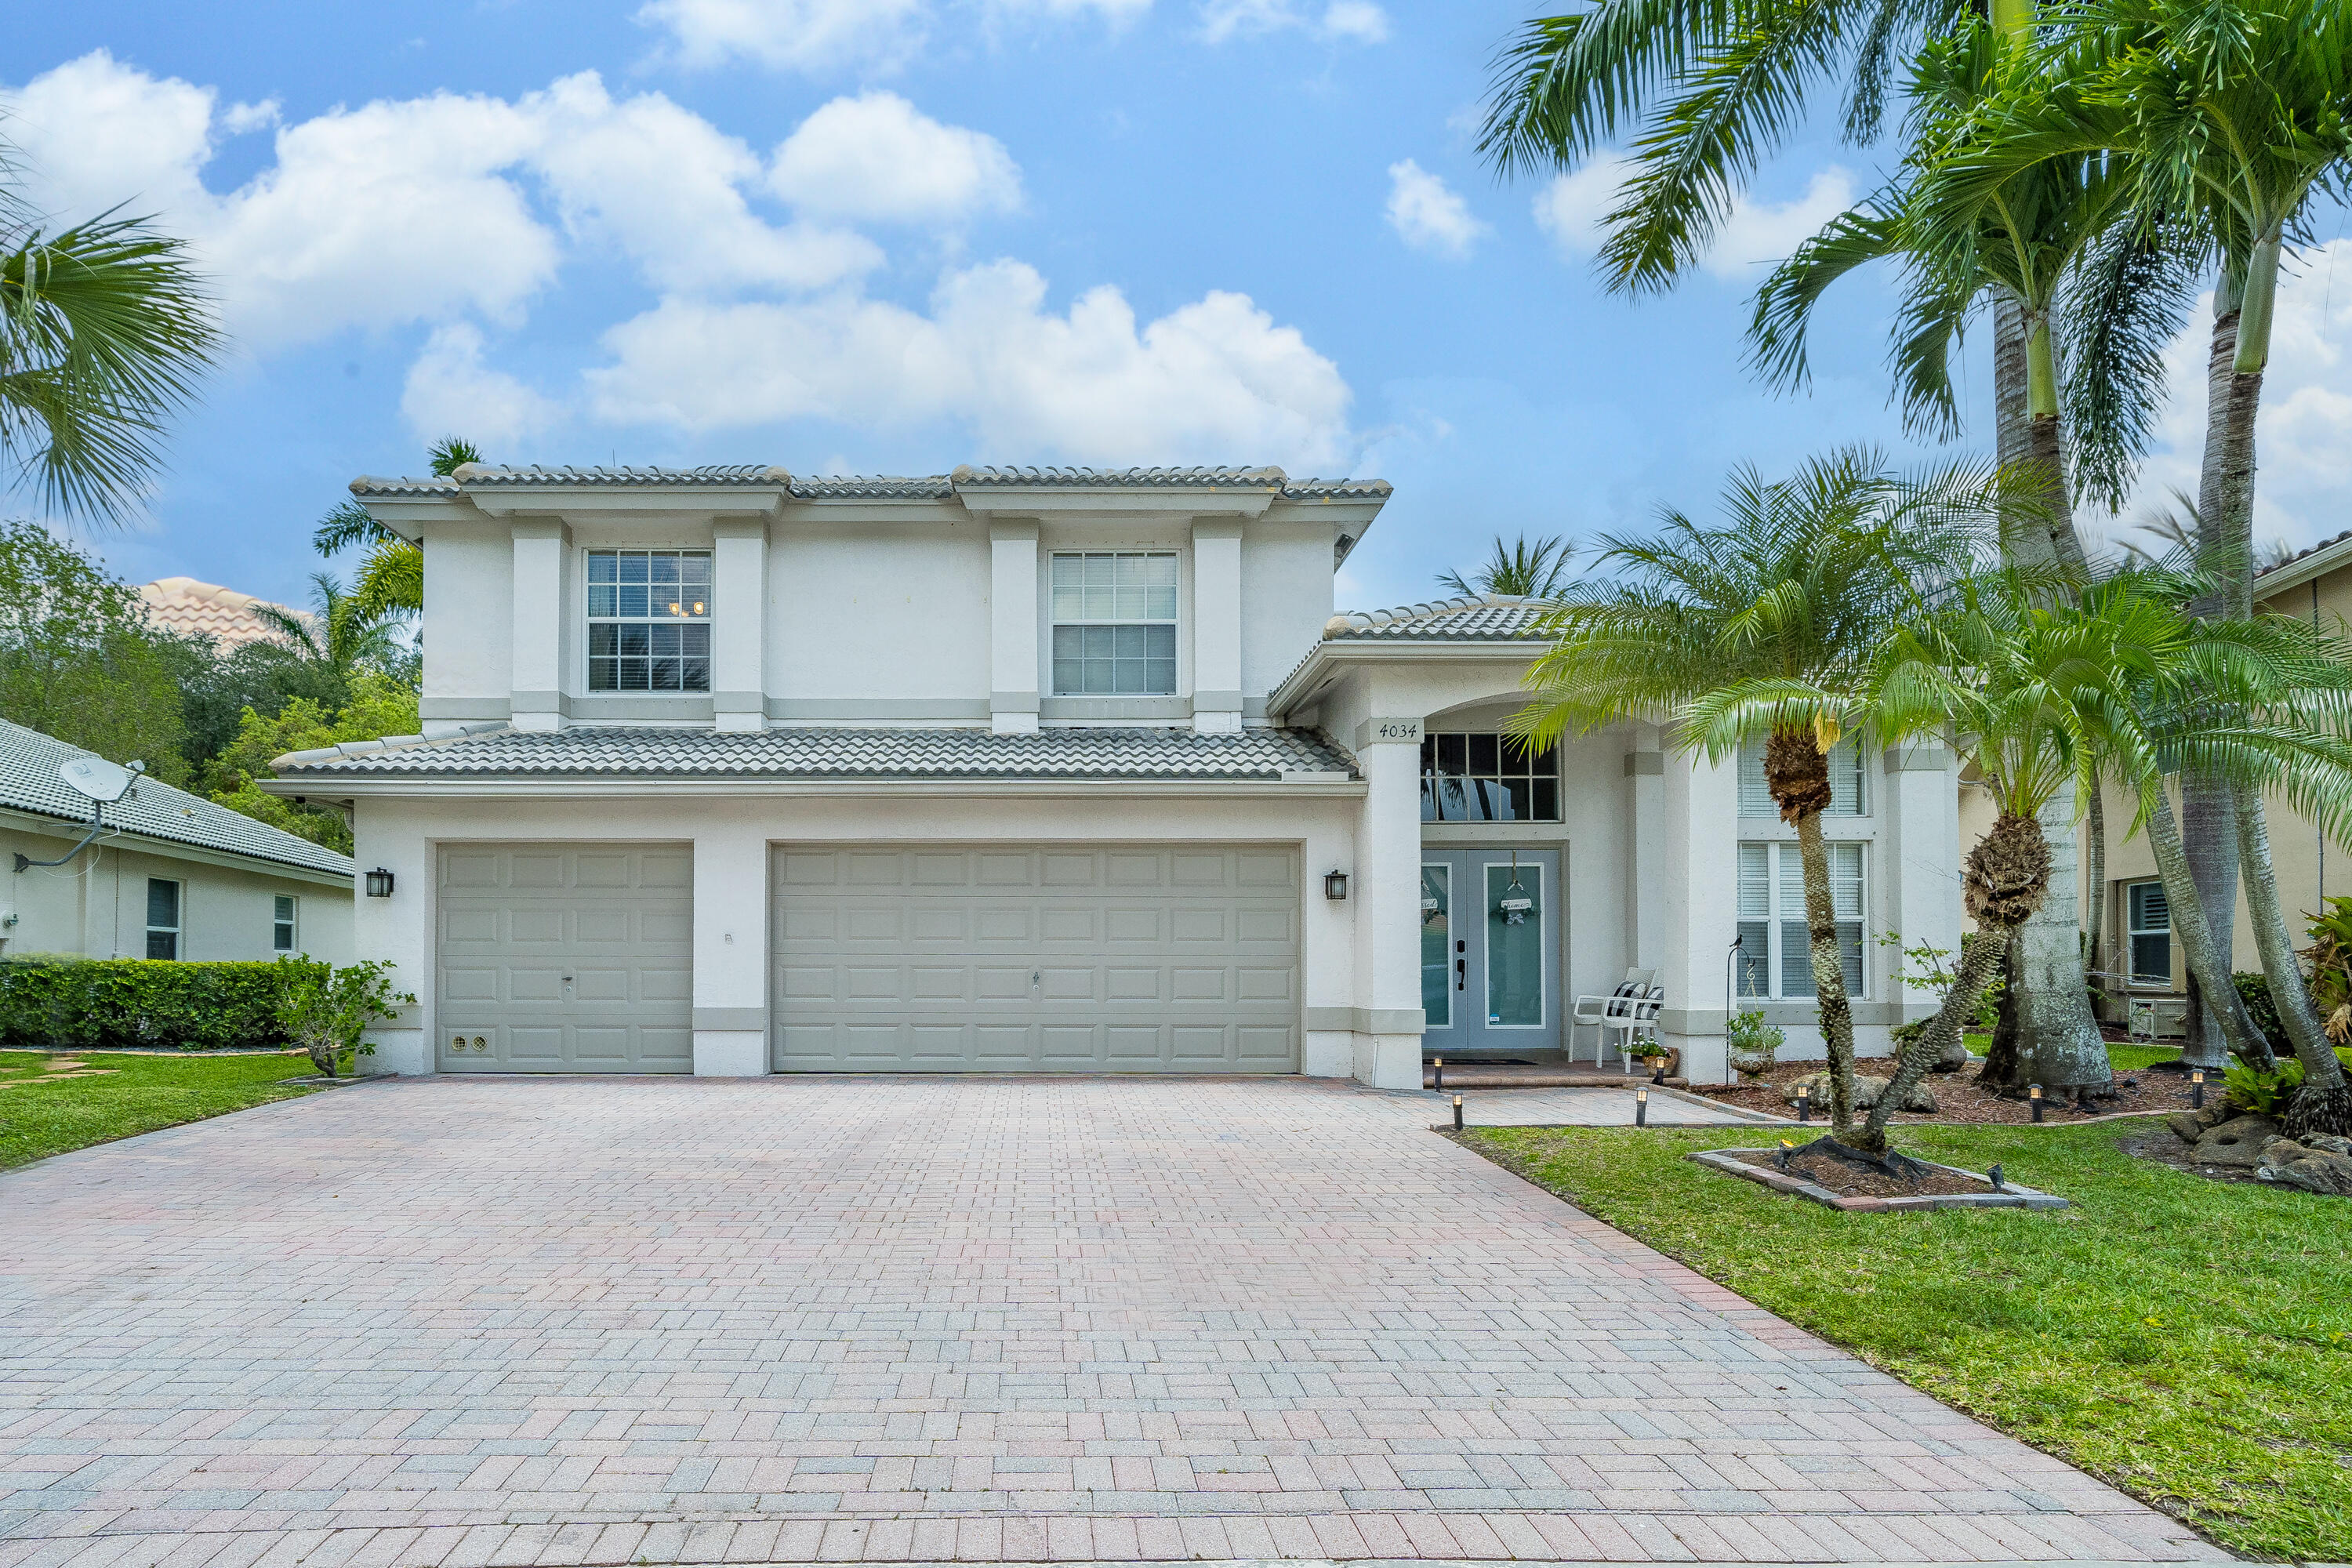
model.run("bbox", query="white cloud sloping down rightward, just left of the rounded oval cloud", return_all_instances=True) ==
[524,71,884,289]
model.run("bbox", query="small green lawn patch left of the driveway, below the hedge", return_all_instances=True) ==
[0,1051,313,1171]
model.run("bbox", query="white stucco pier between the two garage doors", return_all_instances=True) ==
[694,820,769,1079]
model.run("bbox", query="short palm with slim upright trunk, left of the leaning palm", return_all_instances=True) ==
[1515,452,1994,1133]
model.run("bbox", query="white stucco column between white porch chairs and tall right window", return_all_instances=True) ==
[1642,755,1740,1083]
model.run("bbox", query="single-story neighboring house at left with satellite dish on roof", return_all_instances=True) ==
[0,722,350,964]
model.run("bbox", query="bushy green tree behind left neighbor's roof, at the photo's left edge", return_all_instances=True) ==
[0,522,207,783]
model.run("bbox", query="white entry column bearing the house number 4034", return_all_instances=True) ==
[1352,717,1425,1088]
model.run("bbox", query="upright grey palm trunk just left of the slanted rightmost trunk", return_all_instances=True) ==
[2166,281,2263,1072]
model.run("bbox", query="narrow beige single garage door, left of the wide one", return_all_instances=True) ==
[433,844,694,1072]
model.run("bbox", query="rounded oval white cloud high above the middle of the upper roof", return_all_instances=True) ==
[769,92,1021,223]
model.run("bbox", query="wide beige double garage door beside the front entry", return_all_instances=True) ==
[769,844,1298,1072]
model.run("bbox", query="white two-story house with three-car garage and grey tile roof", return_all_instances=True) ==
[266,466,1959,1086]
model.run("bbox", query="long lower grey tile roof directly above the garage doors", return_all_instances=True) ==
[273,729,1355,781]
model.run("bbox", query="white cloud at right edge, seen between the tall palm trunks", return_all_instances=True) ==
[2103,240,2352,548]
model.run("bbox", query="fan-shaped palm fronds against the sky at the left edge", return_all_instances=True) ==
[0,166,221,522]
